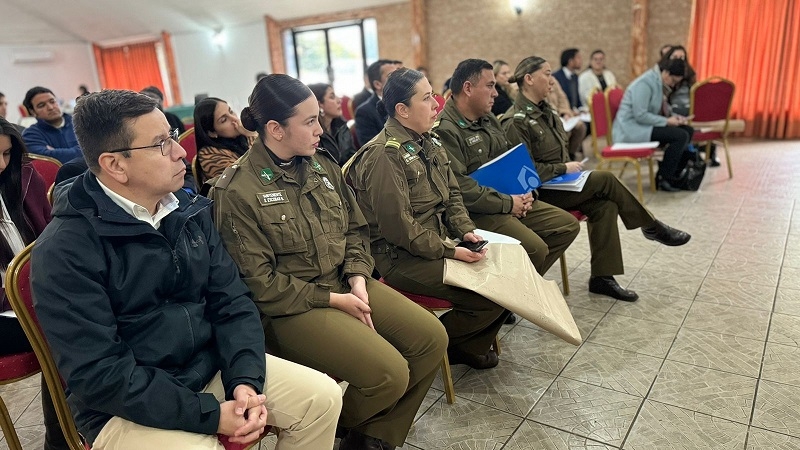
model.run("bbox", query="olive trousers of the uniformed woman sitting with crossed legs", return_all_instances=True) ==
[539,170,655,277]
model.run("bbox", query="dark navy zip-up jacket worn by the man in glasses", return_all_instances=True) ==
[31,172,266,443]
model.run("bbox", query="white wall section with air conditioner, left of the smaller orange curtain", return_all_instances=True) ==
[0,43,99,123]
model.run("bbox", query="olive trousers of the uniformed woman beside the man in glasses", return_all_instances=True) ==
[263,279,447,447]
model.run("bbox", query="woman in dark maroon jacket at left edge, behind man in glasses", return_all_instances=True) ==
[0,117,69,450]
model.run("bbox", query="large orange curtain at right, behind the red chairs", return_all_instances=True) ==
[689,0,800,139]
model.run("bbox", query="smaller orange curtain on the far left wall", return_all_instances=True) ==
[94,42,164,92]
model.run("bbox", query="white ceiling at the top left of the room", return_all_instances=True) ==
[0,0,407,45]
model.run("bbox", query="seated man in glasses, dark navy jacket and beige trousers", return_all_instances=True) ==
[31,90,341,450]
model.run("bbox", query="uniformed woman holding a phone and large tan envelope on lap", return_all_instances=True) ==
[347,69,508,369]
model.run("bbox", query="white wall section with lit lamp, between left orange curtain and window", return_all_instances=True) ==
[172,20,271,113]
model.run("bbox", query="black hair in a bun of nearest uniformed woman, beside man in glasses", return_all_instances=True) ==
[241,73,314,136]
